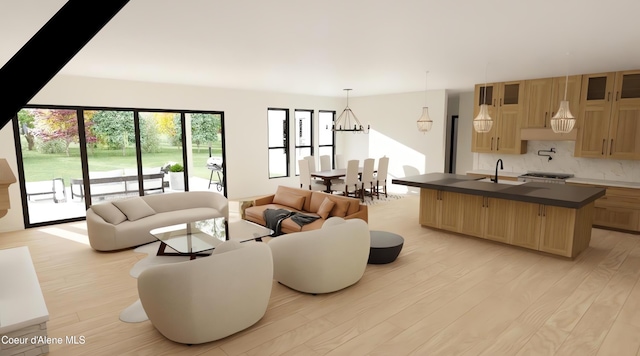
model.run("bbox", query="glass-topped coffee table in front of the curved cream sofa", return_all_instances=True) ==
[150,218,273,260]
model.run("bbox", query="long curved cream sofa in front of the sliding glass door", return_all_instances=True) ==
[87,191,229,251]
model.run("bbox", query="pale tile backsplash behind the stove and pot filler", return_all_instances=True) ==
[474,141,640,182]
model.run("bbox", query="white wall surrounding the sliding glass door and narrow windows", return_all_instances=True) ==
[0,76,447,231]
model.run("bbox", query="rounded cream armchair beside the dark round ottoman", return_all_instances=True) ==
[268,217,371,294]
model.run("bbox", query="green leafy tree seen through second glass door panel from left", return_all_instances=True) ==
[92,110,135,156]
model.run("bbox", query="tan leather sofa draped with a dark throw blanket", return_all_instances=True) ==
[244,186,369,234]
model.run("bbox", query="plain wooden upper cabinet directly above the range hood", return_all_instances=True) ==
[522,75,582,128]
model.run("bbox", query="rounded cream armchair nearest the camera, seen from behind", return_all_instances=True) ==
[138,241,273,344]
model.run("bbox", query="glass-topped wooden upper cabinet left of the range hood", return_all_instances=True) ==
[471,81,527,154]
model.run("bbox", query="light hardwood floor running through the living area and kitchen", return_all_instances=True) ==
[0,196,640,356]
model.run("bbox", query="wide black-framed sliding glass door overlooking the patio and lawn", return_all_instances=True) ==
[14,107,226,227]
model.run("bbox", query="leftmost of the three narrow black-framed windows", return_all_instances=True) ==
[267,108,289,178]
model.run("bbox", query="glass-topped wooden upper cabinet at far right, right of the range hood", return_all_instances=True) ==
[575,70,640,160]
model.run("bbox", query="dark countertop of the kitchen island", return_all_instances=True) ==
[392,173,606,209]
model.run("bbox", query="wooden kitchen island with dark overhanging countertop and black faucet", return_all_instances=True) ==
[392,173,605,258]
